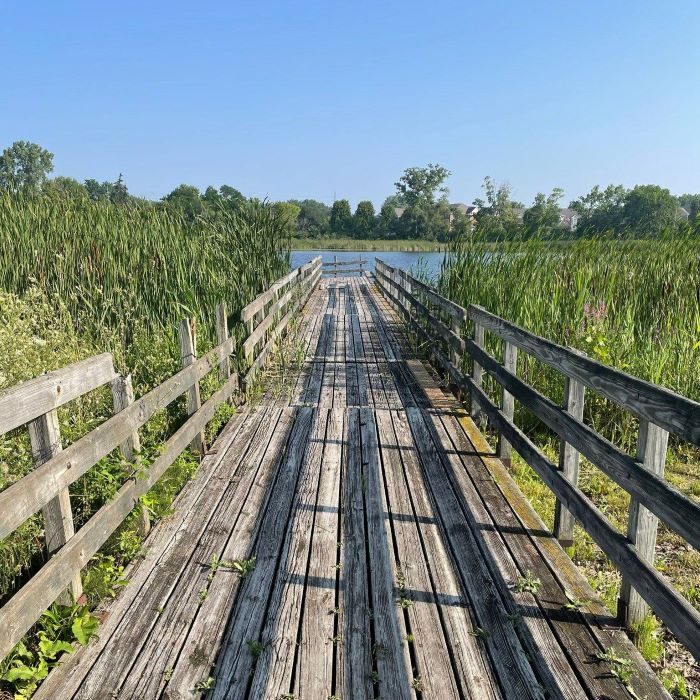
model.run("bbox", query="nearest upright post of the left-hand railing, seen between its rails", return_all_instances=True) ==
[27,409,83,605]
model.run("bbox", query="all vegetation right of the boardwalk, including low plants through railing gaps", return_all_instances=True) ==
[439,232,700,698]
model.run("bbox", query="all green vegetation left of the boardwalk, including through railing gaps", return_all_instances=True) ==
[0,193,289,698]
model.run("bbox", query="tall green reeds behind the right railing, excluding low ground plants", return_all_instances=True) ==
[440,237,700,441]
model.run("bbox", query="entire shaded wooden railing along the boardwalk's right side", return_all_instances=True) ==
[376,260,700,659]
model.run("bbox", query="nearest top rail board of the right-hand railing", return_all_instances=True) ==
[469,306,700,445]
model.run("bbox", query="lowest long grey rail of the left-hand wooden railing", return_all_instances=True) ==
[0,375,238,658]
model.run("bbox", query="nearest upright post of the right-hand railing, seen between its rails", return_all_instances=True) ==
[617,418,668,628]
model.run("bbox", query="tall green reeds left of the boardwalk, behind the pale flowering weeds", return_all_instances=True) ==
[0,195,289,346]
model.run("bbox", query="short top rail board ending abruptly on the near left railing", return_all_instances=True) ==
[0,352,117,435]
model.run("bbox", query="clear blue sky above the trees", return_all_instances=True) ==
[0,0,700,206]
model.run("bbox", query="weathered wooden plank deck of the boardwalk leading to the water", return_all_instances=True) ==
[36,277,667,700]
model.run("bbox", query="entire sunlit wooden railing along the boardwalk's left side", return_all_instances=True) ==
[0,258,320,659]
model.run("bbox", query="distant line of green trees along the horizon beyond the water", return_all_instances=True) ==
[0,141,700,241]
